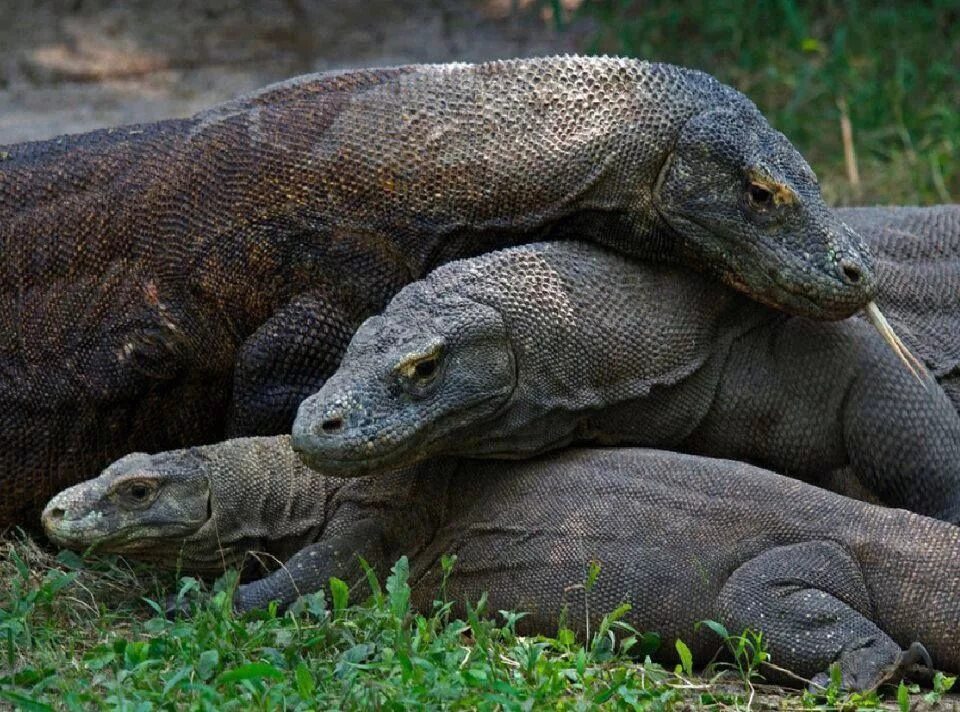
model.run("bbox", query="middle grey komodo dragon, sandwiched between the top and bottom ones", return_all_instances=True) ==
[293,241,960,523]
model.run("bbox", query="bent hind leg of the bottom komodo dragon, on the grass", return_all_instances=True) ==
[718,540,929,690]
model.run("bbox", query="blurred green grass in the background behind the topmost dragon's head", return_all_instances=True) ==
[572,0,960,204]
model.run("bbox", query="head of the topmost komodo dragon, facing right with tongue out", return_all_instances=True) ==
[653,105,877,319]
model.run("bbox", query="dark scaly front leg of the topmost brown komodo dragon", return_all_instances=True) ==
[227,292,365,437]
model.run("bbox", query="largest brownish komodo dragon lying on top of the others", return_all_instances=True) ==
[0,57,876,528]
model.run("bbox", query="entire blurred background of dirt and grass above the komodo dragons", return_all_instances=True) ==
[0,0,960,203]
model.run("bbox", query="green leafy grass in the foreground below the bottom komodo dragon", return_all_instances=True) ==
[0,538,951,710]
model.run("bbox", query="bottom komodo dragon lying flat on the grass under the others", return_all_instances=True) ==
[44,437,960,689]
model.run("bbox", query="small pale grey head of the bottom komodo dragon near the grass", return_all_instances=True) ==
[42,450,220,569]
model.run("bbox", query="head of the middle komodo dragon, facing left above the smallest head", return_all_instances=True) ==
[292,281,517,476]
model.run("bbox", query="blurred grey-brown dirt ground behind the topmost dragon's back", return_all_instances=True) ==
[0,0,590,144]
